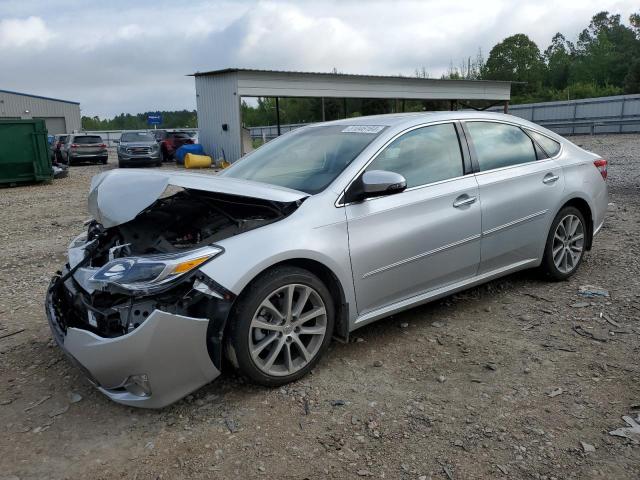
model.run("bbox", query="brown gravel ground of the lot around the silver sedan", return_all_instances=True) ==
[0,135,640,480]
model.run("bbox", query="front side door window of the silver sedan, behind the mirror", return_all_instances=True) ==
[367,123,464,188]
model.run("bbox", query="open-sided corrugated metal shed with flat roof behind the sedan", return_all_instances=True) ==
[193,68,511,162]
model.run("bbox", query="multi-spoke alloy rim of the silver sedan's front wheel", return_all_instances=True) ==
[249,283,327,376]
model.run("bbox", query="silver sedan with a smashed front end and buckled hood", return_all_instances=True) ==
[47,112,607,407]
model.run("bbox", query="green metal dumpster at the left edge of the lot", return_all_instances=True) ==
[0,119,53,184]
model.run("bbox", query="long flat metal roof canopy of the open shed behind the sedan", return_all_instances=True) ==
[194,68,511,101]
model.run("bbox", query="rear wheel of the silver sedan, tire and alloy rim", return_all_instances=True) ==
[541,207,587,280]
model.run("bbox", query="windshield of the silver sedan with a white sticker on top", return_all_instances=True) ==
[221,125,385,195]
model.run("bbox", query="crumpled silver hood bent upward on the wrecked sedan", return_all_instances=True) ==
[88,170,309,228]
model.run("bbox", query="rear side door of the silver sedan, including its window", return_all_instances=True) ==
[464,121,564,274]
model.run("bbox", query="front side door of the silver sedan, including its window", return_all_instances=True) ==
[346,123,481,315]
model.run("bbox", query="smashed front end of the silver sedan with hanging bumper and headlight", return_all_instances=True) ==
[47,171,306,408]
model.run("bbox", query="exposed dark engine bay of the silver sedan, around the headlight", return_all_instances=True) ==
[50,189,301,341]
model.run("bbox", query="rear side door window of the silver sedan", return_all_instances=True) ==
[466,122,537,172]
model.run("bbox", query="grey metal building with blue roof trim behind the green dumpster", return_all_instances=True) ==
[0,90,81,135]
